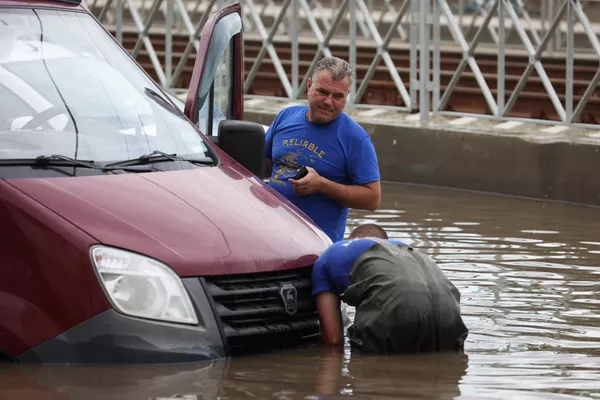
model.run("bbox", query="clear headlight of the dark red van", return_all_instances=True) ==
[91,246,198,324]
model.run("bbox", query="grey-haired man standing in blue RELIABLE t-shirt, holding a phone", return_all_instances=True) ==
[265,57,381,242]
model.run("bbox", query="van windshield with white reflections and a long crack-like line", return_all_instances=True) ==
[0,9,210,163]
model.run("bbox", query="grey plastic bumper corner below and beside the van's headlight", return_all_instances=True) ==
[17,279,226,364]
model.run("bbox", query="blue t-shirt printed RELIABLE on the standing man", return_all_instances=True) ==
[265,106,380,242]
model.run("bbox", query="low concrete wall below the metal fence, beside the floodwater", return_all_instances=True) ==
[245,100,600,205]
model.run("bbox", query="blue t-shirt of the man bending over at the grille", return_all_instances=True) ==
[312,238,405,295]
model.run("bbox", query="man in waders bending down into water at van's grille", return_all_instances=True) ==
[312,224,469,353]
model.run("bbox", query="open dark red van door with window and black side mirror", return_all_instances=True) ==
[184,3,265,177]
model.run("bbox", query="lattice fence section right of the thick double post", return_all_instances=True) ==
[423,0,600,124]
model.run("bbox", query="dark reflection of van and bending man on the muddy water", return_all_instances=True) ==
[0,348,468,400]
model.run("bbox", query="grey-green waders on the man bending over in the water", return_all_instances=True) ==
[343,242,469,354]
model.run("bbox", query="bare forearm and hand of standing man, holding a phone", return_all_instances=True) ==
[289,167,381,211]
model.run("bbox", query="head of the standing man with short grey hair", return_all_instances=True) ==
[307,57,352,124]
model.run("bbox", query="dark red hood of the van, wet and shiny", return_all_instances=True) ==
[9,166,328,276]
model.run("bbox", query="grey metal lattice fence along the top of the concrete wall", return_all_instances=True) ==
[87,0,600,124]
